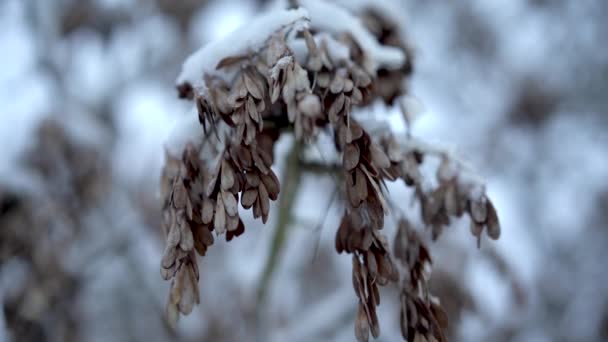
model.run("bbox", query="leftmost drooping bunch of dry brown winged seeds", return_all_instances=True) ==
[161,134,279,322]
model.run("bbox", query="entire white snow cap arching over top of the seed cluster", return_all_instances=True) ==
[177,0,405,89]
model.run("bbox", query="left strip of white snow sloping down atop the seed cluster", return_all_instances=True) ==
[177,8,308,87]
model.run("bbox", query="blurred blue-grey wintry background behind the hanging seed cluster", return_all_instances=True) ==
[0,0,608,342]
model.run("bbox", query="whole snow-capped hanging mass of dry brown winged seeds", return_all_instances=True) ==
[161,0,500,341]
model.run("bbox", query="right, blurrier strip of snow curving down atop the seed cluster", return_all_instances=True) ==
[299,0,405,74]
